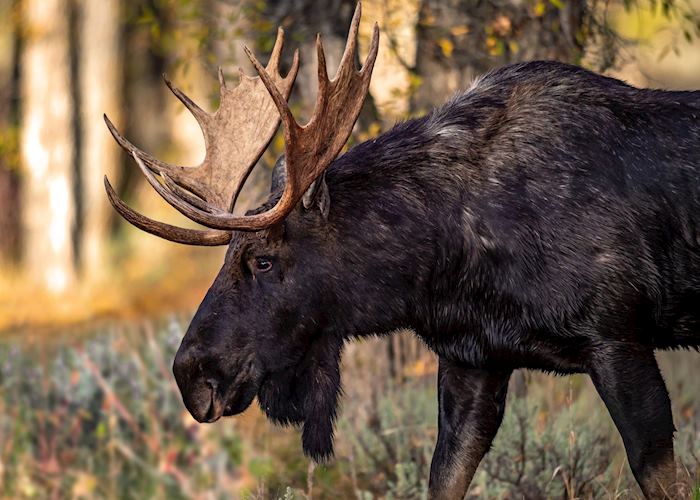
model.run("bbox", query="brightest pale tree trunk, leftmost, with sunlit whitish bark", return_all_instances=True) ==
[20,0,75,293]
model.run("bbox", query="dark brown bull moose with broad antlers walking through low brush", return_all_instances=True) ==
[105,3,700,499]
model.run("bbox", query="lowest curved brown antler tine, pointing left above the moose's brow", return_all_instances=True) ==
[104,176,232,246]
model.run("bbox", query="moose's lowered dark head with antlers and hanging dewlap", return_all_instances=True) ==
[105,3,397,459]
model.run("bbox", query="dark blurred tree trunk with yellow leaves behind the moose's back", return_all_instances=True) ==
[412,0,585,112]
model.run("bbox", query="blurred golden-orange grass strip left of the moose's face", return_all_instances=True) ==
[0,241,223,335]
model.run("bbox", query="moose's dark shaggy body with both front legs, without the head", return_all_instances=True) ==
[366,62,700,498]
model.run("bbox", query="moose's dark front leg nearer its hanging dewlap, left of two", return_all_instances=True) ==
[429,358,511,500]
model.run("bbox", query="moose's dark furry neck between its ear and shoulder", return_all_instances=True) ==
[320,95,500,342]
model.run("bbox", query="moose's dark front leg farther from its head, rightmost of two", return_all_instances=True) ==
[589,345,676,499]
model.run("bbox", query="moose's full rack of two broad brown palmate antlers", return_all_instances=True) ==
[105,2,379,245]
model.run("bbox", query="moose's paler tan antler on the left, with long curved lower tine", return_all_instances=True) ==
[104,28,299,245]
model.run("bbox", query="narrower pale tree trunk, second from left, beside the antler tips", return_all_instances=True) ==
[79,0,121,280]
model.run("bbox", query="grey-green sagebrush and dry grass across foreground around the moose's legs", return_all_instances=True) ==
[0,318,700,500]
